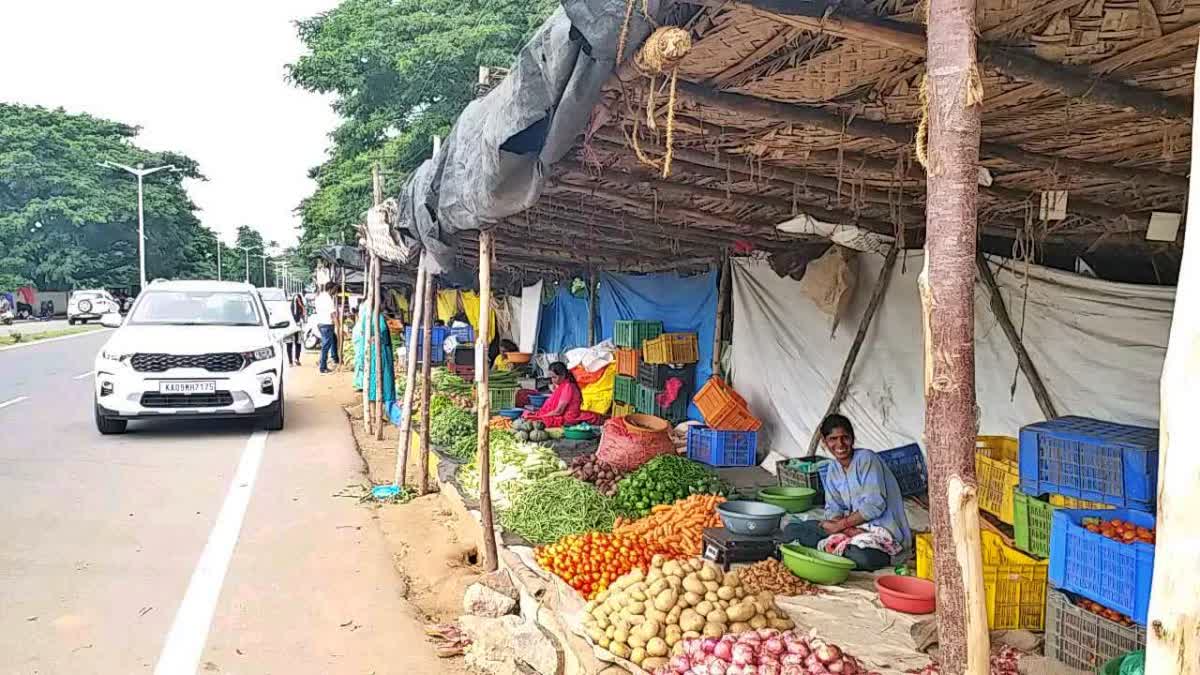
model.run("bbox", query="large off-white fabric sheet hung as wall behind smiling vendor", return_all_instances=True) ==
[733,251,1175,456]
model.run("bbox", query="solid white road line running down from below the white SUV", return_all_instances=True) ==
[154,431,268,675]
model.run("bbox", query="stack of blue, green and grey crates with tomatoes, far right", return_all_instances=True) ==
[1012,417,1158,670]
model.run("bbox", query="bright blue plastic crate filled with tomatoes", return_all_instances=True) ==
[1050,508,1154,626]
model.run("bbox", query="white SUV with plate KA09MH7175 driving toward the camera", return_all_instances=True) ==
[95,281,290,434]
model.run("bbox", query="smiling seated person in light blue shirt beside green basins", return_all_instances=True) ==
[784,414,912,572]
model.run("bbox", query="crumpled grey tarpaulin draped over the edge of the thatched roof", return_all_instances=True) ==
[392,0,659,279]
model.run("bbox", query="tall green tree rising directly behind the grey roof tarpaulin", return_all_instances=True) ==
[288,0,557,259]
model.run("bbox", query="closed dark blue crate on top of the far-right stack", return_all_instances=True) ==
[1019,417,1158,512]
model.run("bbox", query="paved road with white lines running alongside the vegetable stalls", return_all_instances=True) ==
[0,331,440,675]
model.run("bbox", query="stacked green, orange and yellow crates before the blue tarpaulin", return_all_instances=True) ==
[613,321,700,424]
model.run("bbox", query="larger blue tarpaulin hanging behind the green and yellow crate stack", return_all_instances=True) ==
[597,271,716,419]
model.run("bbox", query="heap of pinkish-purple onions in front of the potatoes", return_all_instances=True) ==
[654,628,877,675]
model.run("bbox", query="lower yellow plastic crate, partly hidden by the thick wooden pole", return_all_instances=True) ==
[917,530,1050,631]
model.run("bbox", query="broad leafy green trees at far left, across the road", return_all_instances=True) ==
[0,104,215,289]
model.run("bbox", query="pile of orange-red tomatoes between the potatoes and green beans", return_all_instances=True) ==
[533,532,673,599]
